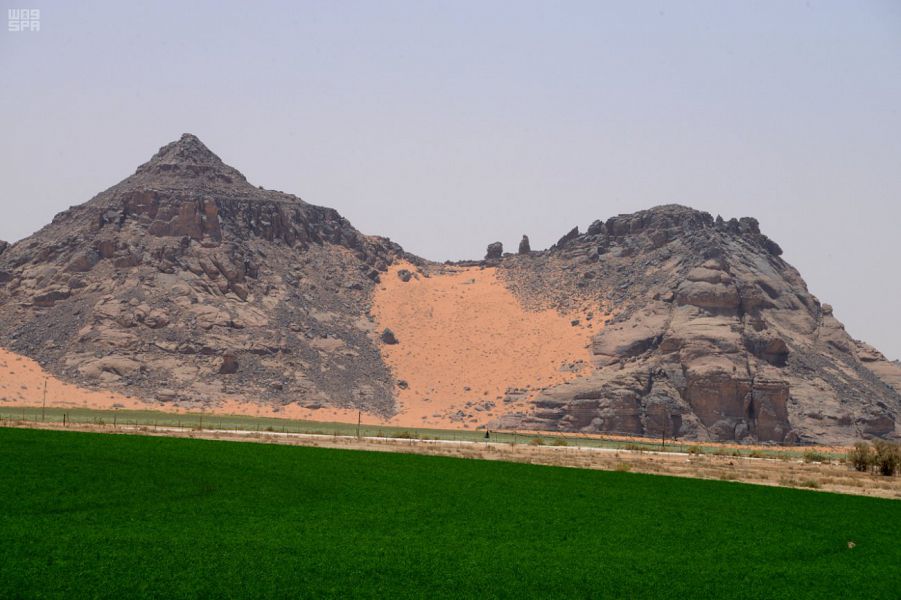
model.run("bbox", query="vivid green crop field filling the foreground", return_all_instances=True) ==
[0,428,901,598]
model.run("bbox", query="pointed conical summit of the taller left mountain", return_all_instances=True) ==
[135,133,247,185]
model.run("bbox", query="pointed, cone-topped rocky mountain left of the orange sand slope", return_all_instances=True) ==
[0,134,402,414]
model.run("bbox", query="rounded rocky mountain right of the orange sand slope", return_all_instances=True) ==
[498,206,901,442]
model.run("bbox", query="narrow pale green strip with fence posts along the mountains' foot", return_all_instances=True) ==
[0,407,843,458]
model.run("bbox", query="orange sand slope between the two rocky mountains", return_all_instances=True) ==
[372,264,602,427]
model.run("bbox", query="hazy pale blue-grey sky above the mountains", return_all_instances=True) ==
[0,0,901,358]
